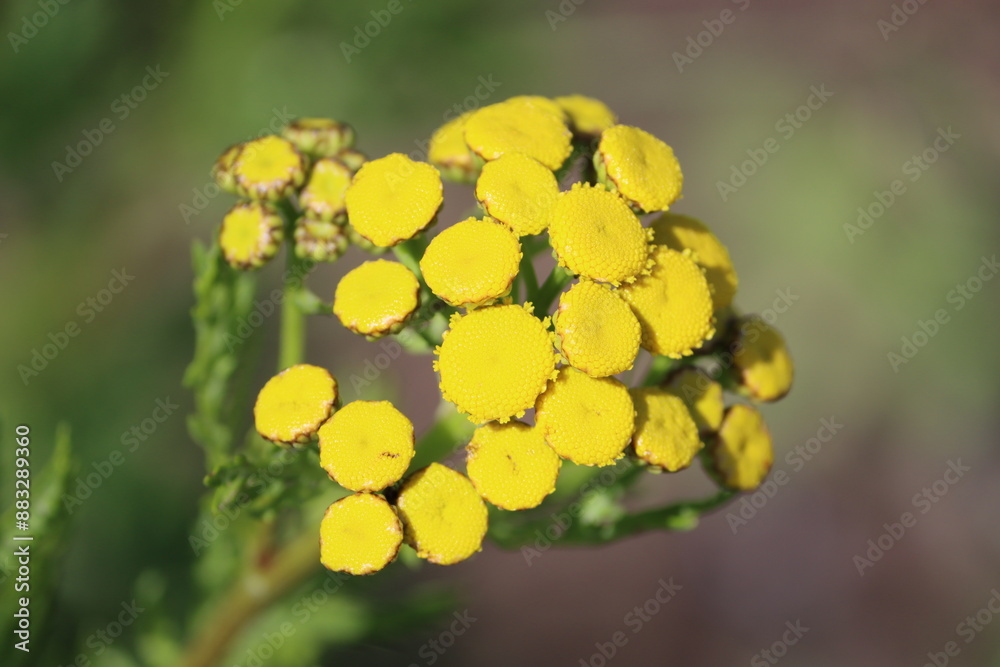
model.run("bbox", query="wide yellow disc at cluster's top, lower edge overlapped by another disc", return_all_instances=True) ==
[465,99,572,171]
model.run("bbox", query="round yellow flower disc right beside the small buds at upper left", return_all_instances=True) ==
[347,153,444,248]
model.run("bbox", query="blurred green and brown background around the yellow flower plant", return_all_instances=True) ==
[0,0,1000,667]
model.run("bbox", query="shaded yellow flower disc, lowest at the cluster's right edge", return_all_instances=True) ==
[712,404,774,491]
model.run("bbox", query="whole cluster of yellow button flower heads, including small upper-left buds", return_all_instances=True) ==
[216,95,793,574]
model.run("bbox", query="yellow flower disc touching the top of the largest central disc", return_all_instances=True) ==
[420,218,521,306]
